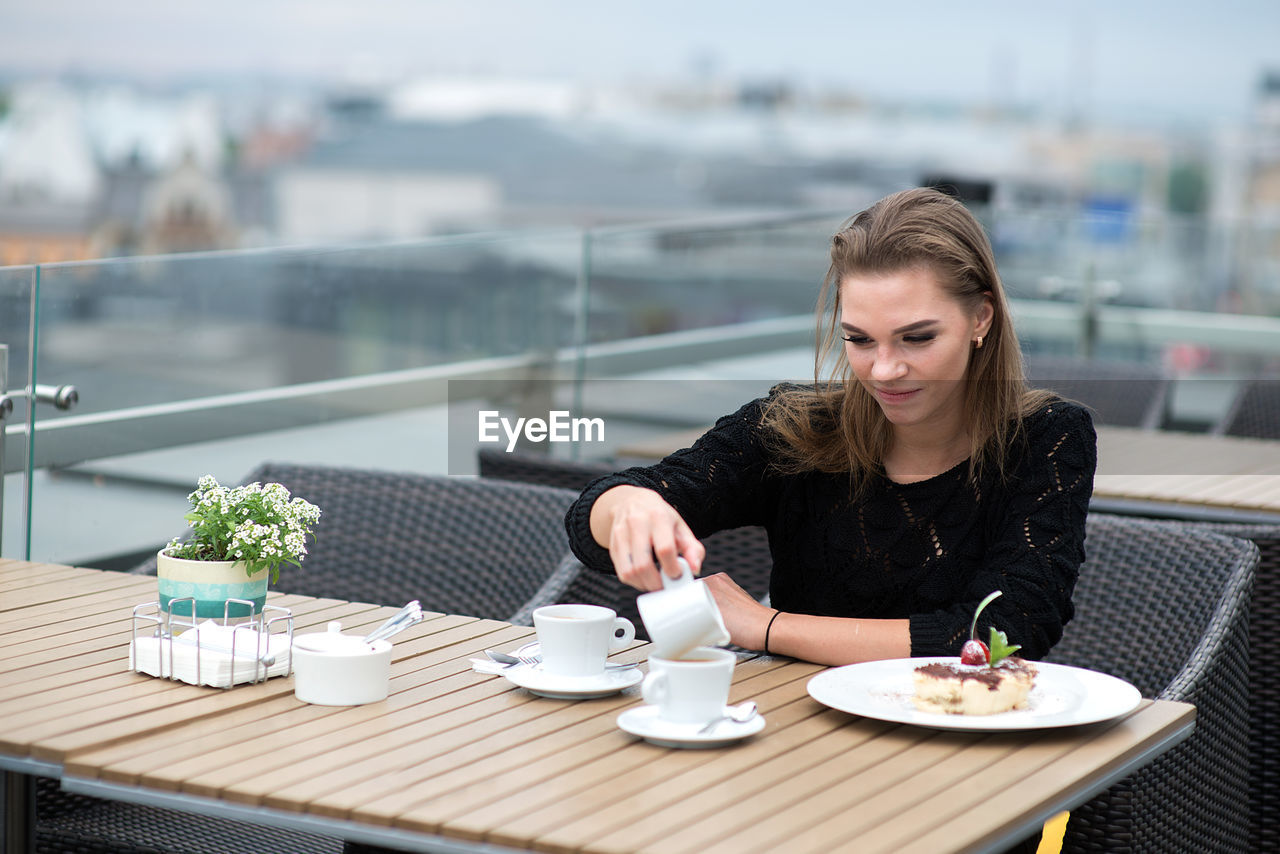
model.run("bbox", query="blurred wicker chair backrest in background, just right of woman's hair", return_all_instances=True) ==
[1027,356,1171,430]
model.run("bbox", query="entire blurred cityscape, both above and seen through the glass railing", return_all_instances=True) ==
[0,36,1280,566]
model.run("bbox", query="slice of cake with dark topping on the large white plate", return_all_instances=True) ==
[911,658,1036,714]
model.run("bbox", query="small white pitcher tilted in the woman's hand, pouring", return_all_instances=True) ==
[636,557,728,658]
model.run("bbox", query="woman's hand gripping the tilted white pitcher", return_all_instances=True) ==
[591,485,707,590]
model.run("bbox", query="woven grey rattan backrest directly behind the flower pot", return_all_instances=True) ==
[142,463,586,620]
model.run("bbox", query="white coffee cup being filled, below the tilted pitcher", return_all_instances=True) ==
[640,647,736,723]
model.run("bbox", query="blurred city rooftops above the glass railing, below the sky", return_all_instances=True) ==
[0,70,1280,314]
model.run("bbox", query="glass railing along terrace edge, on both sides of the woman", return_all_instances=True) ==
[0,210,1280,567]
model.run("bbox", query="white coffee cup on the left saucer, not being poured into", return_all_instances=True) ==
[534,604,636,676]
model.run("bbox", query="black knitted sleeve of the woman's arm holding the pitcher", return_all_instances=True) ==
[564,398,768,572]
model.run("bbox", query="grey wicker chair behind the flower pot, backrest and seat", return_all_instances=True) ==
[36,463,579,854]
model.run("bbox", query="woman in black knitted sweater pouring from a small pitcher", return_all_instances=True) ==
[566,189,1096,665]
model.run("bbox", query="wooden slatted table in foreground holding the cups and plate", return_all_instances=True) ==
[0,561,1194,854]
